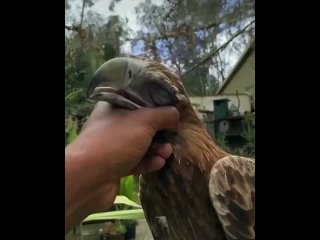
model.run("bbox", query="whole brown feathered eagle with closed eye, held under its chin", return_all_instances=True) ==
[87,57,255,240]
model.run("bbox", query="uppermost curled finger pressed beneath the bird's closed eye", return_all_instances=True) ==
[137,107,179,132]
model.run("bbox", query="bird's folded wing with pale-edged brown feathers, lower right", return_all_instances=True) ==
[209,156,255,239]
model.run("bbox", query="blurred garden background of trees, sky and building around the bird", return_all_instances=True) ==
[65,0,255,240]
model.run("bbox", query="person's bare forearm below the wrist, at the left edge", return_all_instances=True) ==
[65,144,118,232]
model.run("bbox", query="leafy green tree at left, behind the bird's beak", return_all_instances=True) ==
[65,0,130,127]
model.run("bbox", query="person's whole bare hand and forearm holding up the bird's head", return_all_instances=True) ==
[65,102,179,232]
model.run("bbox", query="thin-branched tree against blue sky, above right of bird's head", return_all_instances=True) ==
[132,0,255,95]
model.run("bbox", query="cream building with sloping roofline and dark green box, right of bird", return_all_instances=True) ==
[190,41,255,148]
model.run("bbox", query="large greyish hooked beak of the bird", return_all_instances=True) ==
[87,58,151,110]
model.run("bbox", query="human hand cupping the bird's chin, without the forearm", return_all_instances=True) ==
[78,102,179,178]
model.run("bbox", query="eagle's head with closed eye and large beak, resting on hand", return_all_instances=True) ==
[87,57,191,118]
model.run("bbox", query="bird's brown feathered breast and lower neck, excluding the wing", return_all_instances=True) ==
[140,119,228,240]
